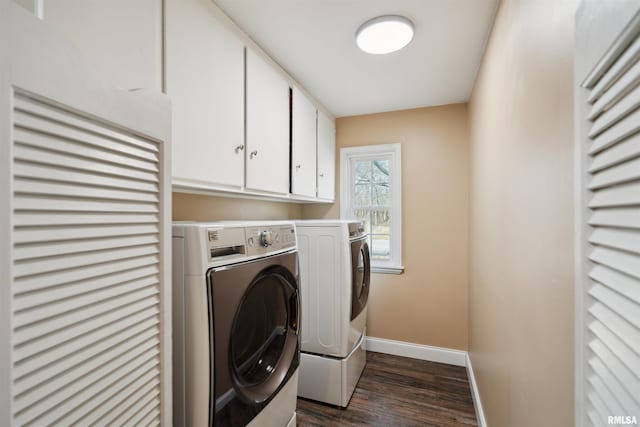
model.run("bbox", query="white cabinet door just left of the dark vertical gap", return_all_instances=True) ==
[246,49,289,194]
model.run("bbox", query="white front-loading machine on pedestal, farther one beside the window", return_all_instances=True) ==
[296,220,371,407]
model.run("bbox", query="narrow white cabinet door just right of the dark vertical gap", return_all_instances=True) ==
[291,87,317,201]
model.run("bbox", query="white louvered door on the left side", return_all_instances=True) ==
[0,6,171,426]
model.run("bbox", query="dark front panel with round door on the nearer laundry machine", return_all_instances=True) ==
[208,253,300,426]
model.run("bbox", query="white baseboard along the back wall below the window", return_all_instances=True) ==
[367,337,467,366]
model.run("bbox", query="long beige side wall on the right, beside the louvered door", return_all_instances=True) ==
[469,0,577,427]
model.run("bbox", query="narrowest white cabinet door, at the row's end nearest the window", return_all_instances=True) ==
[318,110,336,200]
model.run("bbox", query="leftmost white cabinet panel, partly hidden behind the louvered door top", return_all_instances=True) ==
[39,0,162,91]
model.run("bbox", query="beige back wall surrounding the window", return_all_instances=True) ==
[302,104,469,350]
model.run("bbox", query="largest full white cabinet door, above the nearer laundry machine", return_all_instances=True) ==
[165,0,244,189]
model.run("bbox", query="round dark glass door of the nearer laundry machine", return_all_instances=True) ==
[230,267,298,402]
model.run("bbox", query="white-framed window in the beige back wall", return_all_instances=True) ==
[340,144,404,274]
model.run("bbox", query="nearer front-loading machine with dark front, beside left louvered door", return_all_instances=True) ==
[173,222,300,427]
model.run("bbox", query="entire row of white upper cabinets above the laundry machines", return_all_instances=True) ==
[32,0,335,201]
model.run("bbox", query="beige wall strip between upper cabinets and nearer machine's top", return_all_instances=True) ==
[173,193,302,221]
